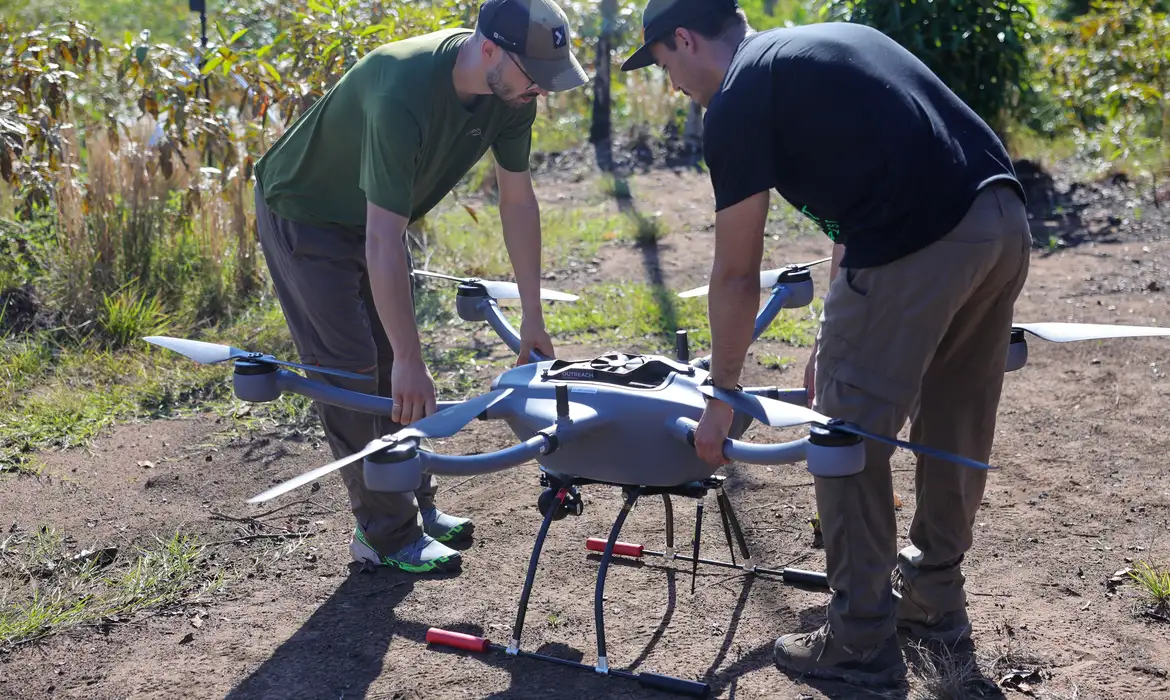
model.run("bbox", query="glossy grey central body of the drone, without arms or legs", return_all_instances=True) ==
[486,352,751,486]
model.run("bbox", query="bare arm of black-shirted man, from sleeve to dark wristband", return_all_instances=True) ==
[707,190,769,389]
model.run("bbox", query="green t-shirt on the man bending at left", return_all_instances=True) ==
[255,29,536,232]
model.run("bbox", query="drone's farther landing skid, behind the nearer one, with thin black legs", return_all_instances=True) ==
[585,476,828,593]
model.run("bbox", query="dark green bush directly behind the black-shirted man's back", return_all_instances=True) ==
[823,0,1035,133]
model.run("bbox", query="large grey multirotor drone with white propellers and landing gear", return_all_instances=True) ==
[145,260,1170,696]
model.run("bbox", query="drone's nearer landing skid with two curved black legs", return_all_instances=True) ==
[427,476,710,698]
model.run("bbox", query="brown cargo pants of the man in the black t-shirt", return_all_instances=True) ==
[814,184,1032,646]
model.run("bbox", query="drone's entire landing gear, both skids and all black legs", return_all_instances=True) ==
[427,473,828,698]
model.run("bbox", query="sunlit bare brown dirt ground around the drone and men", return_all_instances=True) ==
[0,165,1170,700]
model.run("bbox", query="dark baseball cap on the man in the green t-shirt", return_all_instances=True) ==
[477,0,589,92]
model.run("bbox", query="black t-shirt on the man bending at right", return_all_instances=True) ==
[703,22,1025,267]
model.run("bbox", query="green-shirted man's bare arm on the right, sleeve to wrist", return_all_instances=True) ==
[496,163,543,323]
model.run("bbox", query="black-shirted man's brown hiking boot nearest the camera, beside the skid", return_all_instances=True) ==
[772,624,906,686]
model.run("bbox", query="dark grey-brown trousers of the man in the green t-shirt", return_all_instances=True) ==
[256,185,436,556]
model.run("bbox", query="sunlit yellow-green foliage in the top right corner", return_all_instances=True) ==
[1031,0,1170,175]
